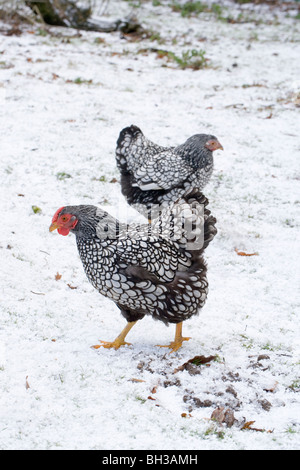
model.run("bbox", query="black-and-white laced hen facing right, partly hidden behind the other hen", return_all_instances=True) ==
[116,125,223,221]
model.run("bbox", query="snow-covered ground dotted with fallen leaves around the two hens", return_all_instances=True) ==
[0,0,300,450]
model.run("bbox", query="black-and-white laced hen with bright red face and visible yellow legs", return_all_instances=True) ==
[49,194,217,352]
